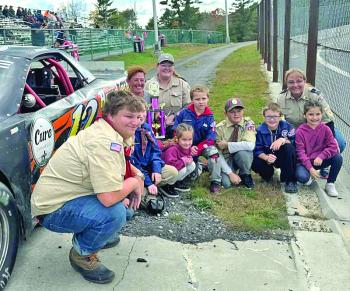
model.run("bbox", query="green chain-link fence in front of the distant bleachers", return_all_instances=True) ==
[0,28,224,60]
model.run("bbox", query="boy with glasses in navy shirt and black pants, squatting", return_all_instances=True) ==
[252,103,298,193]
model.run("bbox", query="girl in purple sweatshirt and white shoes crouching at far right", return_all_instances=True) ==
[295,101,343,197]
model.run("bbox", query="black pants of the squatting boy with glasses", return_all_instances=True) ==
[252,143,296,182]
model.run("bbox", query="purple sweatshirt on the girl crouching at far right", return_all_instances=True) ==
[295,123,339,170]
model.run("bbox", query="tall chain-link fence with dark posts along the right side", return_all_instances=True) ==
[259,0,350,171]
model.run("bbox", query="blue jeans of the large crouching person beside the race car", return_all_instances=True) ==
[41,195,126,256]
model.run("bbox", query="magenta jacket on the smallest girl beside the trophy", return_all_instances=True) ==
[162,143,192,170]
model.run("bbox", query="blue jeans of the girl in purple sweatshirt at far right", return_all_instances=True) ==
[296,154,343,184]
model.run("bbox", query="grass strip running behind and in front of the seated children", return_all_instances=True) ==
[192,45,289,232]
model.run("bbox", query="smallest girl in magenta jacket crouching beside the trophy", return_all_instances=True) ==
[162,123,196,192]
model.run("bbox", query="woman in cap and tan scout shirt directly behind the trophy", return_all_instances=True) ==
[145,54,191,137]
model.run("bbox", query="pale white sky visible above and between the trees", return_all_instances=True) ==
[0,0,232,26]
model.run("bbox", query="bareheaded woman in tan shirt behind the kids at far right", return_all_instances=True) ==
[277,68,346,177]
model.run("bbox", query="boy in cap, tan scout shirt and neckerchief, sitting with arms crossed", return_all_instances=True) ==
[216,98,256,188]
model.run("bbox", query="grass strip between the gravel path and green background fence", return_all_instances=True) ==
[102,44,222,71]
